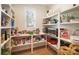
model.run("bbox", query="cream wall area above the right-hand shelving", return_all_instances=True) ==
[49,4,79,15]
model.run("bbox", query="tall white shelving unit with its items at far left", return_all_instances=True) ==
[0,4,15,55]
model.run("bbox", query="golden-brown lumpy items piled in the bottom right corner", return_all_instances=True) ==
[59,43,79,55]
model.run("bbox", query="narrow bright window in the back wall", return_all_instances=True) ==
[26,10,36,27]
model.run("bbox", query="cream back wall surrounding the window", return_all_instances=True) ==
[13,4,47,30]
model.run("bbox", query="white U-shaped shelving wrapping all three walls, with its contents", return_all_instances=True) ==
[0,4,79,55]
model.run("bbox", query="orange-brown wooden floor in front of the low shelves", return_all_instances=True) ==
[13,46,57,55]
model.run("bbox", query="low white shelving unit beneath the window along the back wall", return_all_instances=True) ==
[11,33,46,53]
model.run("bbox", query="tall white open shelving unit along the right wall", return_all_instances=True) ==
[43,5,79,54]
